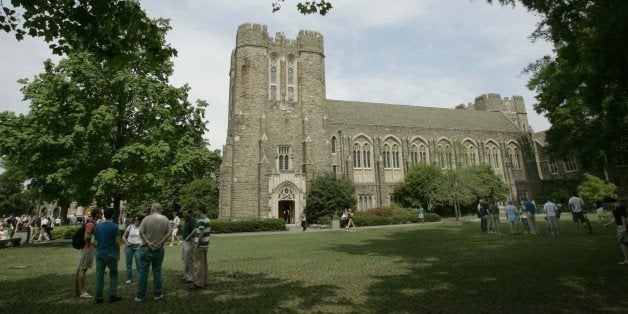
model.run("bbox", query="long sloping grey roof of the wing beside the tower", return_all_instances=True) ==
[327,99,521,132]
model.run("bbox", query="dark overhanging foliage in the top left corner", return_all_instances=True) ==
[0,0,177,70]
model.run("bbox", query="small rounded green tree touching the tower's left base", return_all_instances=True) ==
[180,177,219,219]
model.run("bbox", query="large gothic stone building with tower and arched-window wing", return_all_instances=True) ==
[219,24,542,222]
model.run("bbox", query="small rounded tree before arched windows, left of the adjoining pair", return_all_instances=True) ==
[395,164,446,210]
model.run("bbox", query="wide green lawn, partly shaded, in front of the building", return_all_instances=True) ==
[0,219,628,313]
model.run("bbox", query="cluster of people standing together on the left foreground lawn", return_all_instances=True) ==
[74,203,210,303]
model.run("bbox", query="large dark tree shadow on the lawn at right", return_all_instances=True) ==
[328,227,628,313]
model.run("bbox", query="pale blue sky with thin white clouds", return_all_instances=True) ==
[0,0,552,149]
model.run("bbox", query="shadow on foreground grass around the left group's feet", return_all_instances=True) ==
[0,268,350,313]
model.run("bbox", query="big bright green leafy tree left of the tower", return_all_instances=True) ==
[0,52,217,219]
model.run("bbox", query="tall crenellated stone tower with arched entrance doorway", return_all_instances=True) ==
[219,24,329,223]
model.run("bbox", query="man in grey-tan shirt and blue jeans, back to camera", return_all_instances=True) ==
[135,203,172,302]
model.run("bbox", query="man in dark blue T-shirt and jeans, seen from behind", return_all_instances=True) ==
[94,208,122,303]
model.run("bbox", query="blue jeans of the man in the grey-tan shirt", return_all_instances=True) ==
[136,246,164,300]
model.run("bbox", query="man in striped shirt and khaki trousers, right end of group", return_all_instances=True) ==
[194,208,211,289]
